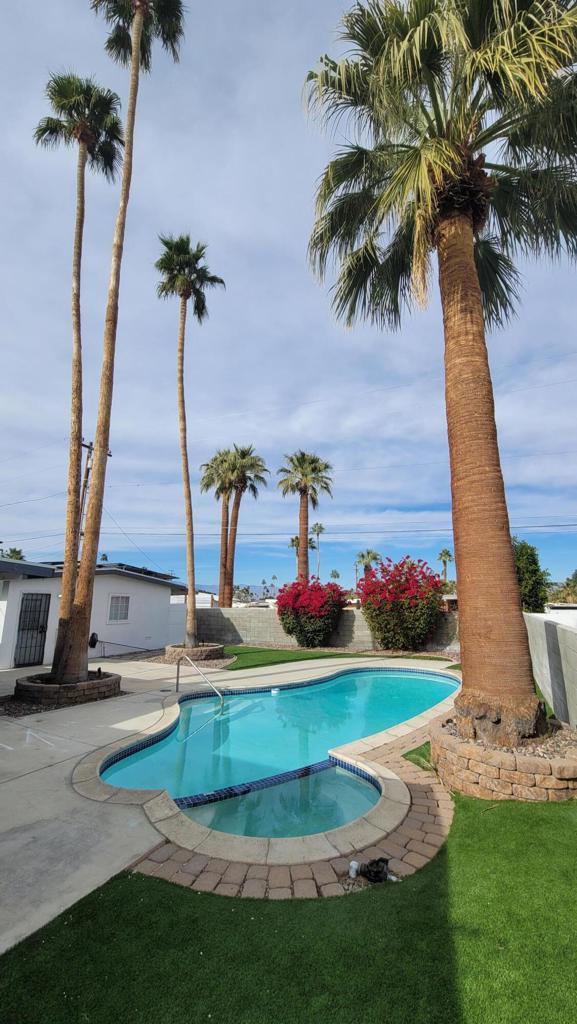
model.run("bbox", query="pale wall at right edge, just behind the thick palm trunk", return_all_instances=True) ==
[525,613,577,726]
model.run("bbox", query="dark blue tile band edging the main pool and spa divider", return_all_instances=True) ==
[98,666,459,778]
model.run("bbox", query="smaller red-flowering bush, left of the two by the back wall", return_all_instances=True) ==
[277,577,345,647]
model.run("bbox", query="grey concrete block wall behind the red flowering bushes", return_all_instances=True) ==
[190,605,457,651]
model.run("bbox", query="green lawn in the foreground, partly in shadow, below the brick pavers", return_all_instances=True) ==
[0,798,577,1024]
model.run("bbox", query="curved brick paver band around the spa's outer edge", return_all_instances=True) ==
[132,728,453,900]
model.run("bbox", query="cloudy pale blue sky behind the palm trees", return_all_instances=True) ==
[0,0,577,585]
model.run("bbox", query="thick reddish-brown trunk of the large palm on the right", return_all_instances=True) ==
[438,214,540,744]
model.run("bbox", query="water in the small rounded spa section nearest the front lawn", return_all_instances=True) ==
[182,767,380,838]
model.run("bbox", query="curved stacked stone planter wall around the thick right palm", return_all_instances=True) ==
[430,726,577,802]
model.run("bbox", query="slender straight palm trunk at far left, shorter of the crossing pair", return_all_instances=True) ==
[51,141,88,679]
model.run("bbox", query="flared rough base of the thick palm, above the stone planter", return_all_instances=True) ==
[455,689,547,748]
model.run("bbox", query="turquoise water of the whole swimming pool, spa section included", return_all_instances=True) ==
[102,669,457,835]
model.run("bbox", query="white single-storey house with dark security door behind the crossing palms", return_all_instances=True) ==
[0,558,186,669]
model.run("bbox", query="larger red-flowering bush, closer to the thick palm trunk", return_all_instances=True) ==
[358,556,443,650]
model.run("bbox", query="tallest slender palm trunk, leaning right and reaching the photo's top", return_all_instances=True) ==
[58,6,145,683]
